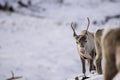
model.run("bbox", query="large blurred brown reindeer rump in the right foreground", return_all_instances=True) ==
[102,27,120,80]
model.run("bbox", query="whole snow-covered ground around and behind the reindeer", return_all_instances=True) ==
[0,0,120,80]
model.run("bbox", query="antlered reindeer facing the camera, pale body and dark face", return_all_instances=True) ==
[71,18,96,76]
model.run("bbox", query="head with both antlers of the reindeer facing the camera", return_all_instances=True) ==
[71,18,90,57]
